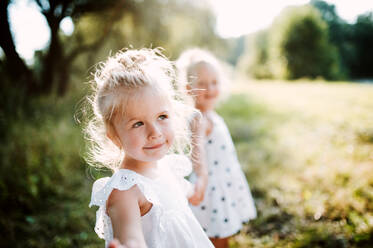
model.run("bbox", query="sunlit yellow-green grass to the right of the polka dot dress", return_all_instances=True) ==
[215,81,373,247]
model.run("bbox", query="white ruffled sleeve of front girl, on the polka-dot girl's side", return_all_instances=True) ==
[161,154,194,197]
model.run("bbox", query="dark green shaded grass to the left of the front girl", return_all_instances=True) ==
[0,85,101,247]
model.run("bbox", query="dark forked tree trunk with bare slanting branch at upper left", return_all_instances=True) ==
[0,0,134,95]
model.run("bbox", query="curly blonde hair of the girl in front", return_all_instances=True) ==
[83,48,195,171]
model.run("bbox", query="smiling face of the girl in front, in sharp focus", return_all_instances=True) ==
[112,87,174,164]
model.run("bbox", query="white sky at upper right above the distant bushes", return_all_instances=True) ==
[210,0,373,38]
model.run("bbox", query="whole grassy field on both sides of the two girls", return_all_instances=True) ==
[0,80,373,248]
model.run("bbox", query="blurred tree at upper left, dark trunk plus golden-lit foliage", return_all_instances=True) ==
[0,0,222,95]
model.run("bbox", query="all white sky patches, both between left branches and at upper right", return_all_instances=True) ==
[5,0,373,63]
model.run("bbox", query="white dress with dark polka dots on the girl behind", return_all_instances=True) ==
[191,113,256,238]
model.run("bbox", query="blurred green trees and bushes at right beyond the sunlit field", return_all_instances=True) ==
[238,0,373,80]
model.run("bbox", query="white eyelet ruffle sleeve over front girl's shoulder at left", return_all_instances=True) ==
[89,169,157,207]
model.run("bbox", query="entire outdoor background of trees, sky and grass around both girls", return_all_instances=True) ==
[0,0,373,248]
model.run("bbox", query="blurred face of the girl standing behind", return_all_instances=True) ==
[192,64,220,112]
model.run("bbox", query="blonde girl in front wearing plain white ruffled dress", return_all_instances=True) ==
[85,49,213,248]
